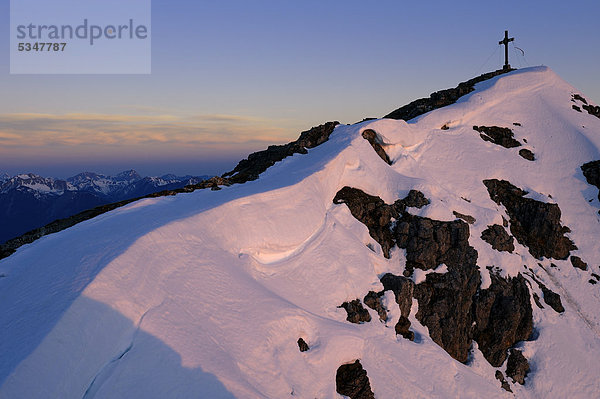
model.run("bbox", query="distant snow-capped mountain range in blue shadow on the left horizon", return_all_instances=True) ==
[0,170,209,243]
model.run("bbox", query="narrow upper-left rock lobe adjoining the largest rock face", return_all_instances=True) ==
[333,186,398,258]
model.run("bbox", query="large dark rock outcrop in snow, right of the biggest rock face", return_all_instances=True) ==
[483,179,577,259]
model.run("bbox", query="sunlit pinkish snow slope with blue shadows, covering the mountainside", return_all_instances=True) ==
[0,67,600,399]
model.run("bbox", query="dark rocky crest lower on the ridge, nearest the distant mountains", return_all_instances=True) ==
[222,121,339,183]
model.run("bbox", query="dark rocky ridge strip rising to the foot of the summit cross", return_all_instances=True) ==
[384,69,514,121]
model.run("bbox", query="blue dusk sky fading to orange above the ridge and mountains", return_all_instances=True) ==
[0,0,600,178]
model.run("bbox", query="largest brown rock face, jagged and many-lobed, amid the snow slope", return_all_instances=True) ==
[334,187,533,367]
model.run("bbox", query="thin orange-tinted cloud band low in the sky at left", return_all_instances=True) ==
[0,113,289,148]
